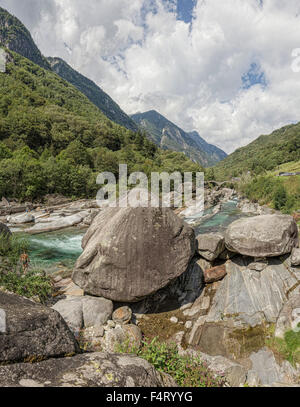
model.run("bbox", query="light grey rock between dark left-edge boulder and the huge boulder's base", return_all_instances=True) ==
[52,295,113,335]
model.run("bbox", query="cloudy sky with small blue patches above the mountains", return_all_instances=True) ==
[0,0,300,153]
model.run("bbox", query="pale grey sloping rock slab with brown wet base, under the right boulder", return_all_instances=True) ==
[187,257,300,359]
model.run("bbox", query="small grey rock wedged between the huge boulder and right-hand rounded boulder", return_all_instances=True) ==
[197,233,225,261]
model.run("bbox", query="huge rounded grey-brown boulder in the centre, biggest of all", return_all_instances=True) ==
[72,207,195,303]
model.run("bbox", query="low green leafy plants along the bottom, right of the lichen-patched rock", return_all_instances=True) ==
[118,338,225,387]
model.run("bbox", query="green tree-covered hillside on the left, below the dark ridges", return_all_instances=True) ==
[0,50,200,200]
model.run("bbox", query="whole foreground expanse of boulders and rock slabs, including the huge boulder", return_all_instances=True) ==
[0,207,300,387]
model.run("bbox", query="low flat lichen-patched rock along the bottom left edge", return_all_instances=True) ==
[0,353,164,387]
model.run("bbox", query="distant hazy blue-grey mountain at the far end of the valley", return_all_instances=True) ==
[131,110,227,167]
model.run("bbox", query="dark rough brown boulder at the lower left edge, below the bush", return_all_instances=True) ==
[0,292,79,363]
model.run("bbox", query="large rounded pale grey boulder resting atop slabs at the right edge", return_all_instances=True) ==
[225,215,299,257]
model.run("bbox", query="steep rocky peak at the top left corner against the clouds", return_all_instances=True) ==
[0,7,51,69]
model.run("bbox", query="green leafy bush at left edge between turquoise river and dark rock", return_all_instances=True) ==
[0,234,52,302]
